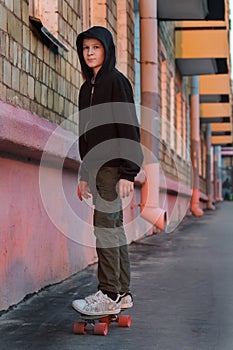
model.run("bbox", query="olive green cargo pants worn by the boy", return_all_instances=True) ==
[89,167,130,293]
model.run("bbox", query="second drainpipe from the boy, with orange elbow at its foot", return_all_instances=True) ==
[190,76,203,216]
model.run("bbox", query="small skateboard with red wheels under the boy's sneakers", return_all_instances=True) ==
[73,310,131,335]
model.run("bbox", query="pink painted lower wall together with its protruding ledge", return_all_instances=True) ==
[0,101,208,310]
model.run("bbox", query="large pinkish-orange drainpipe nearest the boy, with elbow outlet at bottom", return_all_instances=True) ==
[139,0,166,231]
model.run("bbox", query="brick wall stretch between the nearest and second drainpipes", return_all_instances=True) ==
[158,22,191,190]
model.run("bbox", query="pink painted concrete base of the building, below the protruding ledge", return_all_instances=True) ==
[0,152,193,310]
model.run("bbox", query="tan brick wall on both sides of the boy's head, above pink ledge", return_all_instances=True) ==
[0,0,137,133]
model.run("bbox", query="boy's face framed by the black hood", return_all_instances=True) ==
[83,38,105,75]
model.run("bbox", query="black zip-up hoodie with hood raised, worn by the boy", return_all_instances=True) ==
[76,26,143,181]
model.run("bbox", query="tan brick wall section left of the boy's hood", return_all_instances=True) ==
[0,0,81,130]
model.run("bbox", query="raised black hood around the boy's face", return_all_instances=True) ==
[76,26,116,81]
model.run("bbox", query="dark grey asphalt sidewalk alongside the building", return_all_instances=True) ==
[0,202,233,350]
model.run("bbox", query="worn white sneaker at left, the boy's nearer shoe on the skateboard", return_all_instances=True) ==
[72,291,121,316]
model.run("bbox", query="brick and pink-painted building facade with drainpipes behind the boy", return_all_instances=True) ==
[0,0,232,310]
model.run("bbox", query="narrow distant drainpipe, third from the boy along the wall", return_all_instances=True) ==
[206,124,215,210]
